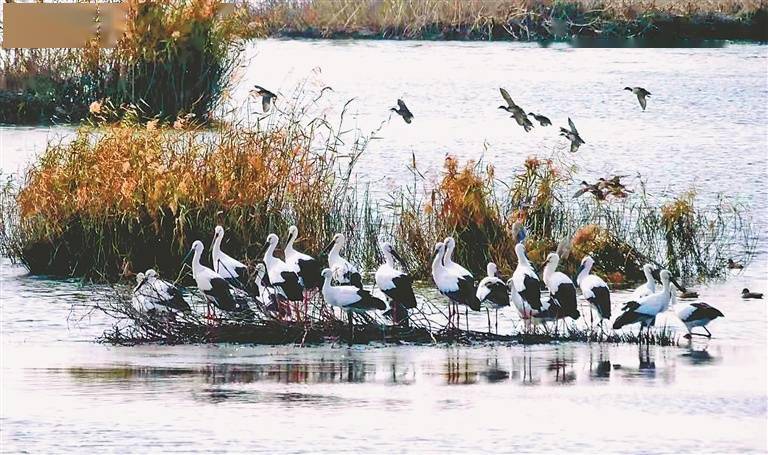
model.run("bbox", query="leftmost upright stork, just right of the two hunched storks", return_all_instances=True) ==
[185,240,253,317]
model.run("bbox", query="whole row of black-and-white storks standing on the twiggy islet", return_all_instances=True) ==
[133,222,732,337]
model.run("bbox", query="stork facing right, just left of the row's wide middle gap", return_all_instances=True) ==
[374,242,416,324]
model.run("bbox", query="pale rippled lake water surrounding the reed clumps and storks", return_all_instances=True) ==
[0,40,768,453]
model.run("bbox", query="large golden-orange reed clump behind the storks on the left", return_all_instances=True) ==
[2,113,375,279]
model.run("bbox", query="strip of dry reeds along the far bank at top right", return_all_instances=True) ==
[250,0,768,42]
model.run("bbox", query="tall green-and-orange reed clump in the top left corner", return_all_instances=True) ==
[0,0,245,124]
